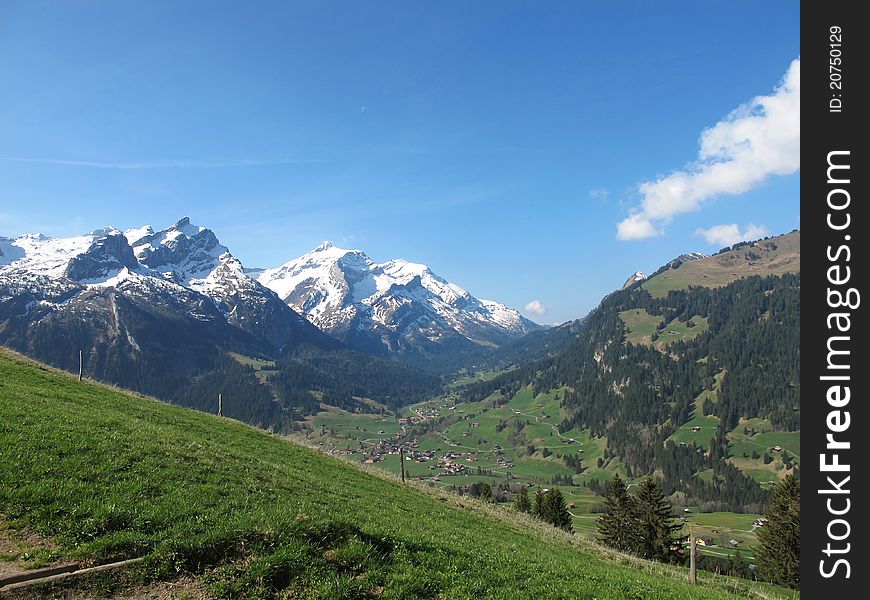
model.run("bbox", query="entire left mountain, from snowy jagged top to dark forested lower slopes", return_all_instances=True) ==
[0,218,450,430]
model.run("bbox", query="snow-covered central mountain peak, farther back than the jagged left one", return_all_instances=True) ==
[257,242,539,362]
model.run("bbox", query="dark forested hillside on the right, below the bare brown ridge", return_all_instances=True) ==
[462,237,800,512]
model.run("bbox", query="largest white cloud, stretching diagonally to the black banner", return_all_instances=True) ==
[616,58,801,240]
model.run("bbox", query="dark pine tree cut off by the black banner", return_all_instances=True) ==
[755,475,801,588]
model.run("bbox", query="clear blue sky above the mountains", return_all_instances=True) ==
[0,0,800,323]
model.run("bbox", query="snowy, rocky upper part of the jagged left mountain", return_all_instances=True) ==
[0,217,336,348]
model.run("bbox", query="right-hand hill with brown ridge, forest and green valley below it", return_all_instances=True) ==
[294,232,800,588]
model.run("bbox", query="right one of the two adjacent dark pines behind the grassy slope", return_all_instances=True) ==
[632,477,682,562]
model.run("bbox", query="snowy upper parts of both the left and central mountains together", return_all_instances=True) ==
[0,218,540,366]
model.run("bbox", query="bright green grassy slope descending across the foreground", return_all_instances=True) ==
[0,349,789,599]
